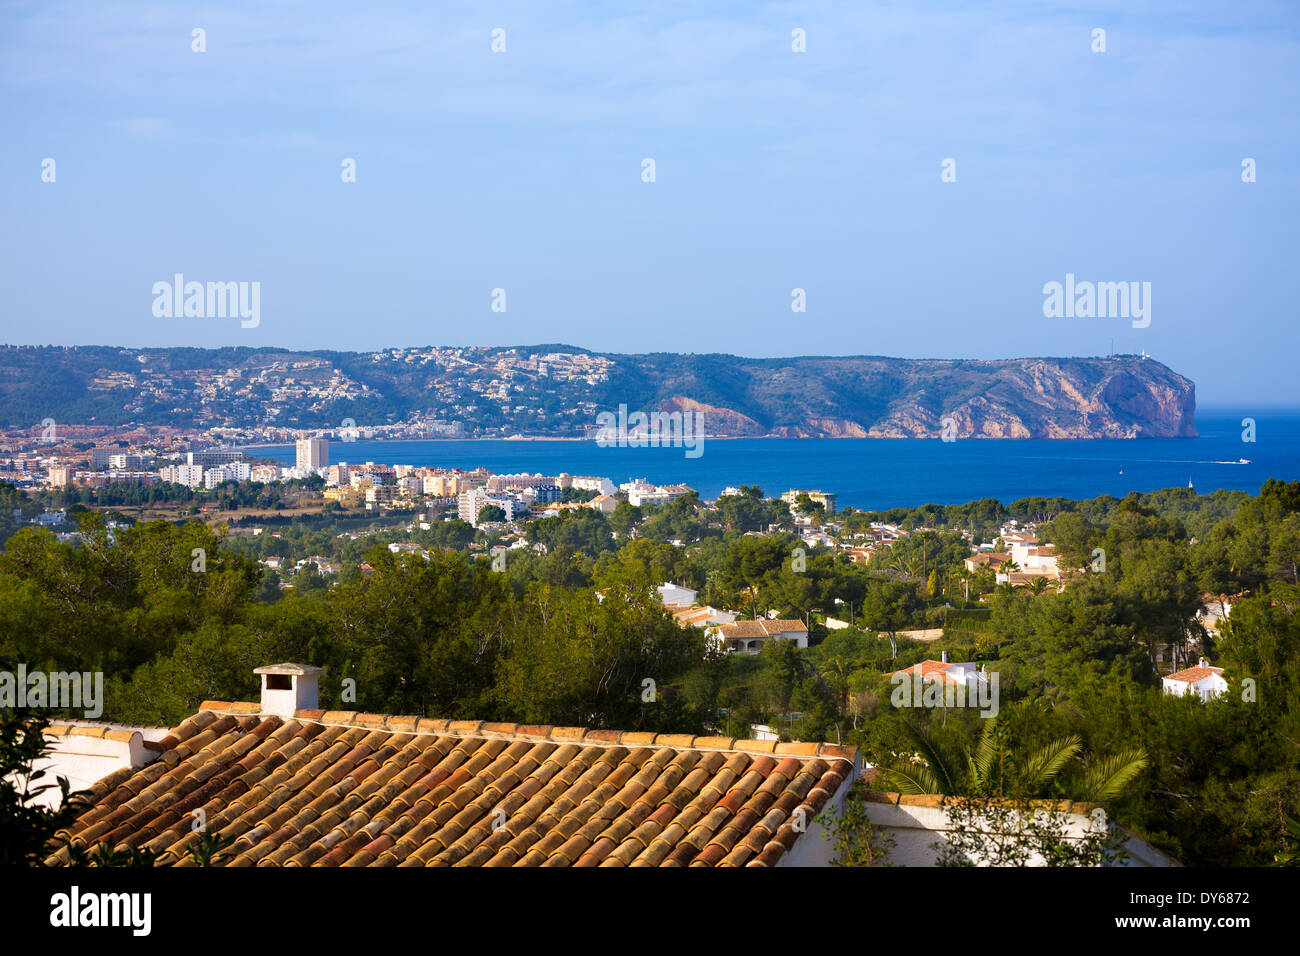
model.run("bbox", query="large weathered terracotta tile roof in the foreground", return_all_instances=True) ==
[47,701,859,866]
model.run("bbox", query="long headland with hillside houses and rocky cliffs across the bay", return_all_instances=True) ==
[0,345,1196,438]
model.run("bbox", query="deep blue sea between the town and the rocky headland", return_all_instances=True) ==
[256,408,1300,509]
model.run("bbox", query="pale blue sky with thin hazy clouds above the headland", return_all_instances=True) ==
[0,0,1300,405]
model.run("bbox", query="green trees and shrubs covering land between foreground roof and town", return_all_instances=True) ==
[0,481,1300,865]
